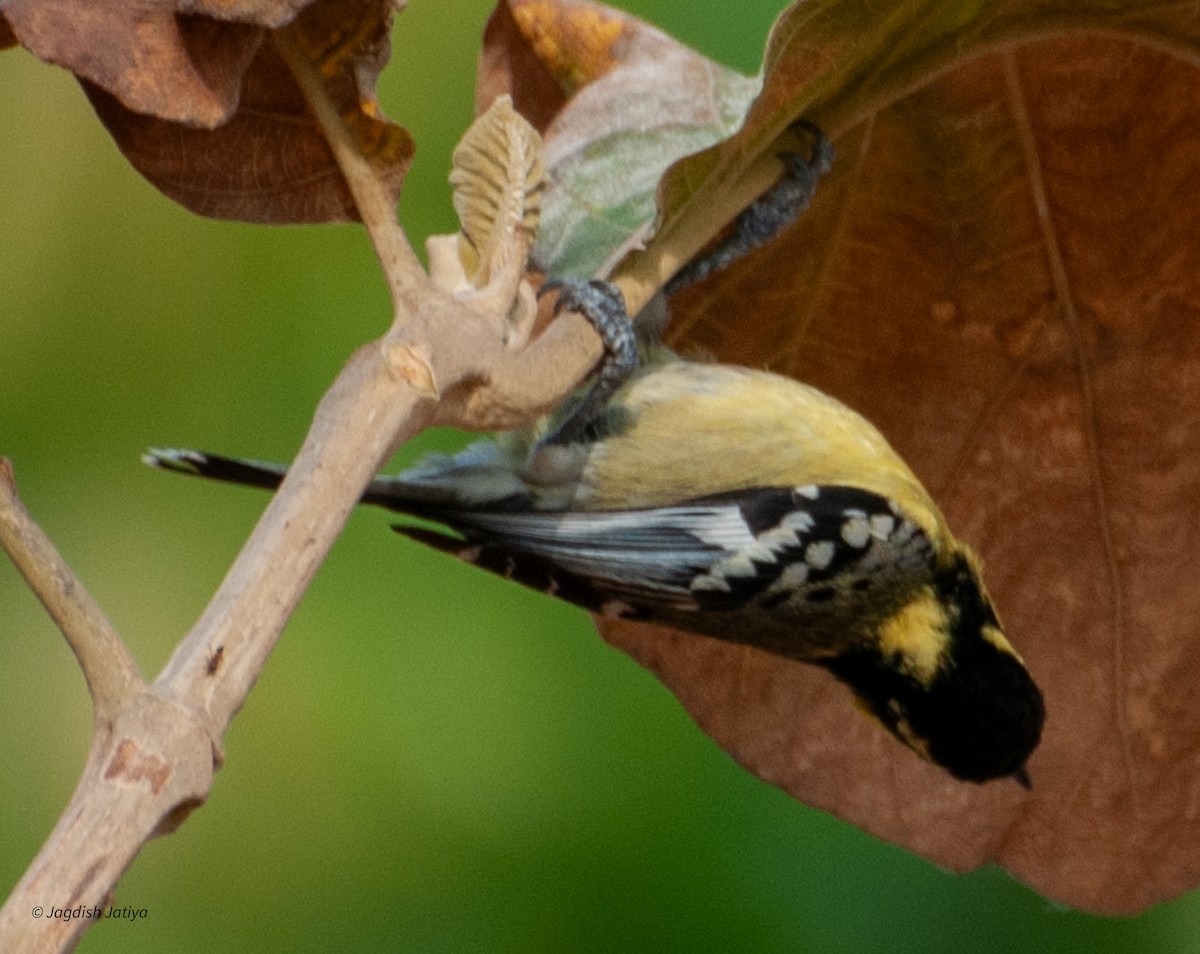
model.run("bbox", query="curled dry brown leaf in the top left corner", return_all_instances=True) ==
[5,0,413,223]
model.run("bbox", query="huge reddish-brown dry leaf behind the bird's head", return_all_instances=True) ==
[482,0,1200,913]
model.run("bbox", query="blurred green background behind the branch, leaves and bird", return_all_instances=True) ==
[0,0,1200,954]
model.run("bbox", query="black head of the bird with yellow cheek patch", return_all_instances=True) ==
[826,553,1045,784]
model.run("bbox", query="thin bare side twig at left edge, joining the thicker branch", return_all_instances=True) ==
[0,458,142,722]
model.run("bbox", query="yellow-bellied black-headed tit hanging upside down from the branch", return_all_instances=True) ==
[145,283,1044,784]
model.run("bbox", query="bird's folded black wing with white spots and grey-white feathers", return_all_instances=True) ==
[396,486,932,638]
